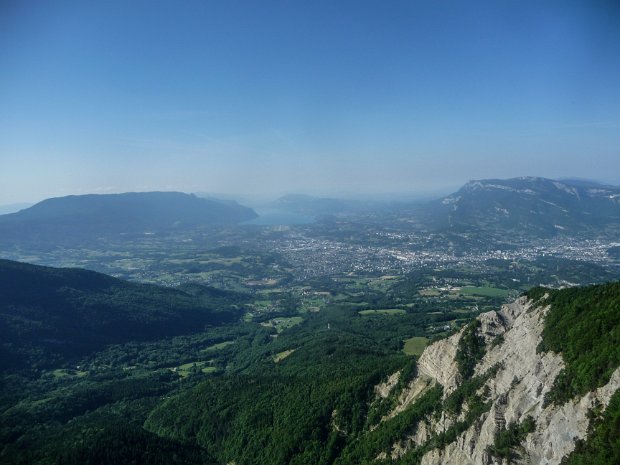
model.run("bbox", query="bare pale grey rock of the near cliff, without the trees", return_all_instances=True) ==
[381,297,620,465]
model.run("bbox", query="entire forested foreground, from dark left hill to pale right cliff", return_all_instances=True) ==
[0,261,620,465]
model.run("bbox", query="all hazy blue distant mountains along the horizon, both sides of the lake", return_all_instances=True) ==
[0,177,620,245]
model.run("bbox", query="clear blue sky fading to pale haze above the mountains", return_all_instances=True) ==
[0,0,620,204]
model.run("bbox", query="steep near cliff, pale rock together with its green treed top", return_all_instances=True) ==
[368,283,620,465]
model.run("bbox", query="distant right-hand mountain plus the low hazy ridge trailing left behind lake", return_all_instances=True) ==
[274,177,620,237]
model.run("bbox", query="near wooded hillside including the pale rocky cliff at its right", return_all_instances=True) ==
[145,283,620,465]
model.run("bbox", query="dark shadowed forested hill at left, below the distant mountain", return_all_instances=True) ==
[0,260,244,368]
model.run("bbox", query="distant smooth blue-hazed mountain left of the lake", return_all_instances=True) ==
[0,192,256,244]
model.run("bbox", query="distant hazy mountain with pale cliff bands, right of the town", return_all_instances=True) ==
[426,177,620,237]
